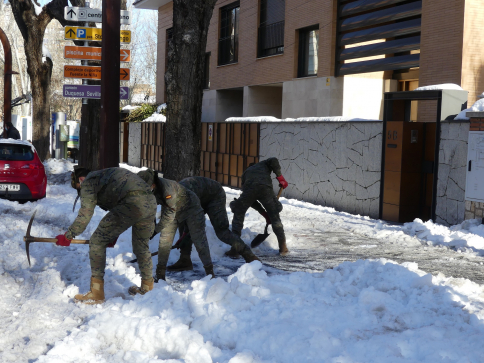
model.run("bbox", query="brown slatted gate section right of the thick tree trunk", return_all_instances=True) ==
[200,122,260,188]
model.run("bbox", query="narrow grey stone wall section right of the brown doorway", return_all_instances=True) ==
[435,121,469,225]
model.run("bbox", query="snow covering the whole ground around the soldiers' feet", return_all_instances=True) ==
[0,160,484,363]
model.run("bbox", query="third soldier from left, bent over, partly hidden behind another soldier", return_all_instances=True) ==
[167,176,259,271]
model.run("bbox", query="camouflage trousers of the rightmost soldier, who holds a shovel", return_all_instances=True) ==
[230,183,286,243]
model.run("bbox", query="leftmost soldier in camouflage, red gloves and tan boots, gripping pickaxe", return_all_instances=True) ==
[57,167,156,304]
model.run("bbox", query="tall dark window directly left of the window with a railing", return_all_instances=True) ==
[218,1,240,66]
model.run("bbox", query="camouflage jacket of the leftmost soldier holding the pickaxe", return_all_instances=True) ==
[66,168,150,239]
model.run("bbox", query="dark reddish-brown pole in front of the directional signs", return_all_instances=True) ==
[99,0,121,169]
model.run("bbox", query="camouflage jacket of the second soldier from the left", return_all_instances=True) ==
[138,169,201,236]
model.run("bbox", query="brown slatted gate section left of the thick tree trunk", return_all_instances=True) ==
[141,122,165,173]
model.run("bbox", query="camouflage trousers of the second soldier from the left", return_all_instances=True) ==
[157,204,212,269]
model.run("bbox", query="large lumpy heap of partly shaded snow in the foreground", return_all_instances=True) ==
[38,260,484,363]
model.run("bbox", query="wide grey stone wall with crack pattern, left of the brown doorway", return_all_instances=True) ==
[260,121,383,218]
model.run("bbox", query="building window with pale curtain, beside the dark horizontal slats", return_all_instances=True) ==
[297,25,319,77]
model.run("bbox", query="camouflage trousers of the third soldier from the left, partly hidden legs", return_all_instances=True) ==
[179,189,249,255]
